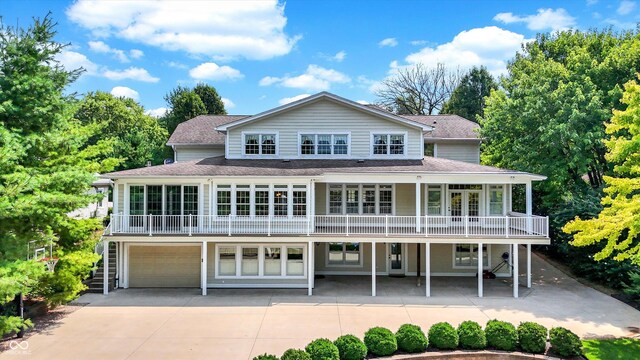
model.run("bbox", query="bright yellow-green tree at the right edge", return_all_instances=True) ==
[564,81,640,264]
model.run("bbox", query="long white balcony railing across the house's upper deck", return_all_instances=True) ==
[109,213,549,238]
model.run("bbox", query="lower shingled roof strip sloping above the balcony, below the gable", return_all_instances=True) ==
[103,156,523,179]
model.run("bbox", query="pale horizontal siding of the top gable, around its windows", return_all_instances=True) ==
[227,100,423,159]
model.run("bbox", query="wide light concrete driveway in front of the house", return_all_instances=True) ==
[0,255,640,360]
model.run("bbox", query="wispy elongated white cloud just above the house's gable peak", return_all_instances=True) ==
[258,64,351,90]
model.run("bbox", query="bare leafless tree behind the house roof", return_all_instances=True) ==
[376,64,460,115]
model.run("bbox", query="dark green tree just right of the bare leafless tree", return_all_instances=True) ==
[441,66,498,122]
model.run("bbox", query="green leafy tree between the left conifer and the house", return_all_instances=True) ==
[75,91,169,170]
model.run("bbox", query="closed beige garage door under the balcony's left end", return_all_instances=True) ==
[129,244,201,288]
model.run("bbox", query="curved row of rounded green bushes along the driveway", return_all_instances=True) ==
[253,320,582,360]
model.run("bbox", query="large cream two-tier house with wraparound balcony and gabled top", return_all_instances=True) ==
[104,92,549,297]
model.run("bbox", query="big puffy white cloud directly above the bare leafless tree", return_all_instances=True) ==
[404,26,529,75]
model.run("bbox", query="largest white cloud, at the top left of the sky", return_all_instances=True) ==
[66,0,301,60]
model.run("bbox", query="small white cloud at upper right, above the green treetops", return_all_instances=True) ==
[493,8,576,31]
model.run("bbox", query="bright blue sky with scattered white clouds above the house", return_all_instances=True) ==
[0,0,640,114]
